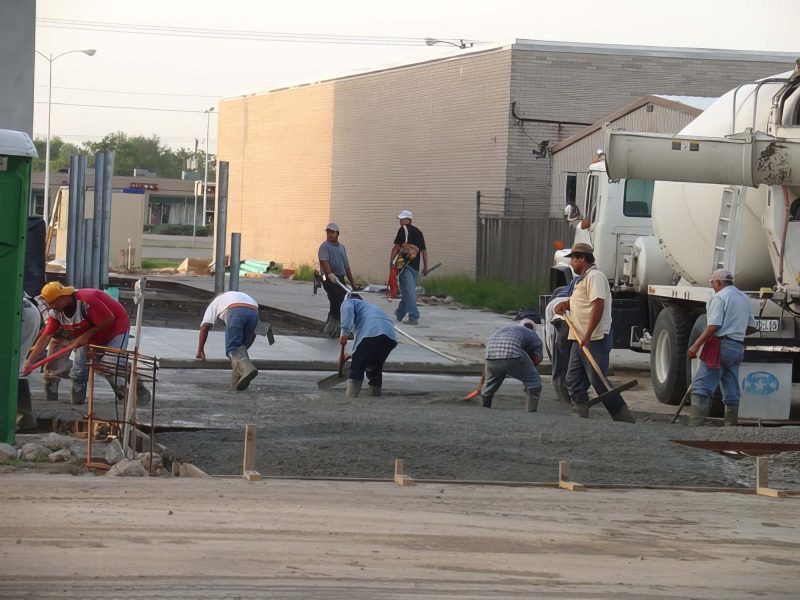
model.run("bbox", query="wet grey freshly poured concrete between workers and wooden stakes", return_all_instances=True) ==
[138,370,800,489]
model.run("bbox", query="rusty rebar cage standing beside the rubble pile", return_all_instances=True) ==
[86,345,158,475]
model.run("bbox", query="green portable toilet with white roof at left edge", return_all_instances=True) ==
[0,129,37,444]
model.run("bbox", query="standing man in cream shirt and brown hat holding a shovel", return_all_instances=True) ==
[554,242,635,423]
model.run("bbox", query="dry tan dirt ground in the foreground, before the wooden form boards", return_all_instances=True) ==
[0,474,800,600]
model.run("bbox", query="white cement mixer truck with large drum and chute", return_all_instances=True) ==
[551,61,800,419]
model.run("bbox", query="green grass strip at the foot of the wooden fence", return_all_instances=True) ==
[418,275,541,313]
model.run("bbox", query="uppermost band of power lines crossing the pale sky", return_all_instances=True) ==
[37,18,487,46]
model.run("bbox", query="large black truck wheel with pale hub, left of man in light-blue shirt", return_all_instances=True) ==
[650,306,692,404]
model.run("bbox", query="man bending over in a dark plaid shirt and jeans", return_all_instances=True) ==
[481,319,542,412]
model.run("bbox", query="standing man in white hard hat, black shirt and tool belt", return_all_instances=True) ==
[389,210,428,325]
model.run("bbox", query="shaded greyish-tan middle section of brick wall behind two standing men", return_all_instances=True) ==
[331,51,510,283]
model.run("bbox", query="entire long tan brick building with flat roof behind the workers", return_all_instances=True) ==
[218,40,795,282]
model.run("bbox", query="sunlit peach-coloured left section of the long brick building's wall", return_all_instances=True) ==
[218,83,334,266]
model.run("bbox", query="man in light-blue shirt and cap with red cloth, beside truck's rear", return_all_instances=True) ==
[686,269,758,426]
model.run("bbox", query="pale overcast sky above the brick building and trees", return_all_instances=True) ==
[33,0,800,152]
